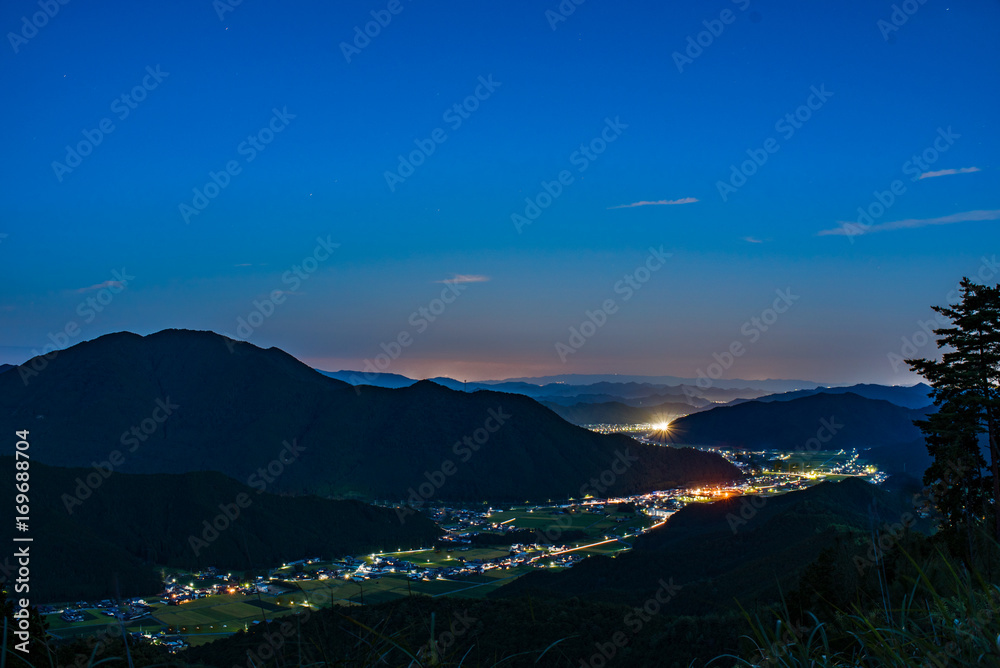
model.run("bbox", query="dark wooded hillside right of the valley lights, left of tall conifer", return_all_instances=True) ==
[495,478,912,614]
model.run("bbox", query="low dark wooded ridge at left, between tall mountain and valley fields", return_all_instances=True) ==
[0,457,441,602]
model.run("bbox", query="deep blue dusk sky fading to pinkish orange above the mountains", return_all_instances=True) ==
[0,0,1000,383]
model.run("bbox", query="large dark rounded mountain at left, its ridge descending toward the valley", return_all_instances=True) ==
[0,330,738,501]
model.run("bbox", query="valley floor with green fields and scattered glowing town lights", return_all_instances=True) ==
[44,436,885,651]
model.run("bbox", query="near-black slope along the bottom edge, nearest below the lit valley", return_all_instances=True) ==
[177,596,745,668]
